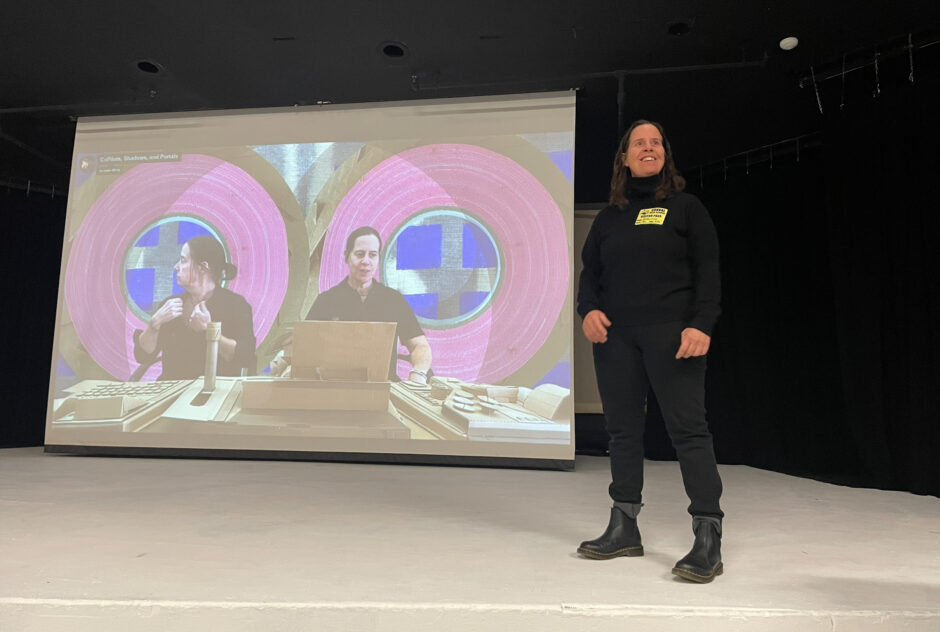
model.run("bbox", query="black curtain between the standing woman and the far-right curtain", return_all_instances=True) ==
[684,150,859,480]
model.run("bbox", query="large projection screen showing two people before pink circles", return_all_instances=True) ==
[46,93,575,464]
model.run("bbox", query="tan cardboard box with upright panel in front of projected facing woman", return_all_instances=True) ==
[241,321,397,411]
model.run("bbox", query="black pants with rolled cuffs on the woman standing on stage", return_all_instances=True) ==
[594,323,724,517]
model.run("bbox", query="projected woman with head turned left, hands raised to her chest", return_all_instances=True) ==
[134,235,255,380]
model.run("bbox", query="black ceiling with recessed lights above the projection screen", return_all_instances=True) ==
[0,0,940,201]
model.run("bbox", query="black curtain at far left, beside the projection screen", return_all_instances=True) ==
[0,189,65,448]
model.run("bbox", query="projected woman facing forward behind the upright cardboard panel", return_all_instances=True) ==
[307,226,431,384]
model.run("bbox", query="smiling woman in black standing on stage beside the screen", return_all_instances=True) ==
[578,120,724,582]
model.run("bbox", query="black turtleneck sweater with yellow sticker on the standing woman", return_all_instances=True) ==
[578,174,721,335]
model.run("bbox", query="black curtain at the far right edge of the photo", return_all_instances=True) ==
[825,77,940,495]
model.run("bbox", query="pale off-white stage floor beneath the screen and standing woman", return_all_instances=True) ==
[0,448,940,632]
